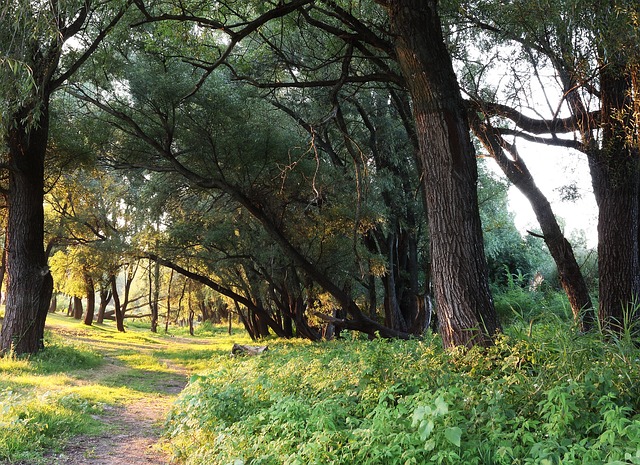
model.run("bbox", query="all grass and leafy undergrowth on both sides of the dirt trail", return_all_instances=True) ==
[5,295,640,465]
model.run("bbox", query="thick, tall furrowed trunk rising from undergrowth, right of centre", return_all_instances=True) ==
[380,0,500,348]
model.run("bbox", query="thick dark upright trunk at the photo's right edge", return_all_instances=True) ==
[589,62,640,332]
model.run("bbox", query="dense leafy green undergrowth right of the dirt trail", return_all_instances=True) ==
[168,323,640,464]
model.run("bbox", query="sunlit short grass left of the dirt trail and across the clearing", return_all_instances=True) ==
[0,314,246,464]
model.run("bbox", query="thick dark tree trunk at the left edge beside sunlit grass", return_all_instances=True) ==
[0,108,53,354]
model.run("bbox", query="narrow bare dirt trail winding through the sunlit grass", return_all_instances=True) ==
[43,324,212,465]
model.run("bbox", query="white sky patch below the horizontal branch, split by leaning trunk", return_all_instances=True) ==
[487,140,598,247]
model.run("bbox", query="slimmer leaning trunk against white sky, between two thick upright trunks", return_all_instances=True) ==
[470,114,595,331]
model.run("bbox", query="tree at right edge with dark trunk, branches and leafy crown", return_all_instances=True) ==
[459,0,640,331]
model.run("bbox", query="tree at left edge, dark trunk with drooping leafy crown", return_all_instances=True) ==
[0,0,129,354]
